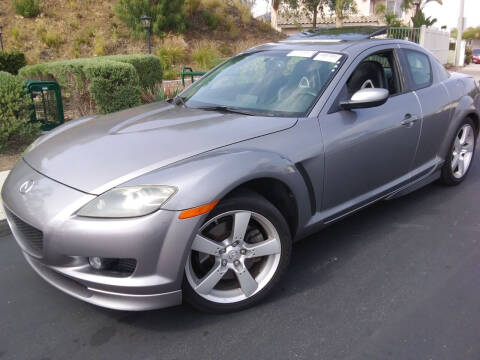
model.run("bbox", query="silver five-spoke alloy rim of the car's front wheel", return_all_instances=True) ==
[185,210,282,303]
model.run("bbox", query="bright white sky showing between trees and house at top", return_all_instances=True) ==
[252,0,480,29]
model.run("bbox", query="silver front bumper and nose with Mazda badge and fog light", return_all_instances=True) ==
[2,160,201,310]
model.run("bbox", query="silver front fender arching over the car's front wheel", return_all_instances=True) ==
[124,149,310,218]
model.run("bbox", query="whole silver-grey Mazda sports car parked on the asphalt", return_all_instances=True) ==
[2,28,480,312]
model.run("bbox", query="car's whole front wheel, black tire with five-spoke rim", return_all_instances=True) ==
[183,192,292,313]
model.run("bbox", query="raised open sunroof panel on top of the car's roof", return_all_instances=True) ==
[287,26,388,41]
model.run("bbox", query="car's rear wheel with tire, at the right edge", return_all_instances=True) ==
[440,118,477,186]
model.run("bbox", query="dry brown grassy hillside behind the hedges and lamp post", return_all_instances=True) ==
[0,0,281,65]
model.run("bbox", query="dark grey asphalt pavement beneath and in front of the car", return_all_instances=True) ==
[0,148,480,360]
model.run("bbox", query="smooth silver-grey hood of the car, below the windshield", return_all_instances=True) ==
[24,102,296,194]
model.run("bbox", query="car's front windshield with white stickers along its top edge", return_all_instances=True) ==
[180,50,343,117]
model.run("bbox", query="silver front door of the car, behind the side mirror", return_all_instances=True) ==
[320,45,421,222]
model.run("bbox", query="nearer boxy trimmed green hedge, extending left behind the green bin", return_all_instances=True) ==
[19,57,141,116]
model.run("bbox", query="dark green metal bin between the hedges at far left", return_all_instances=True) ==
[24,80,65,131]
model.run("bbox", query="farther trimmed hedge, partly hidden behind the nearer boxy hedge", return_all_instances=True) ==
[97,54,163,90]
